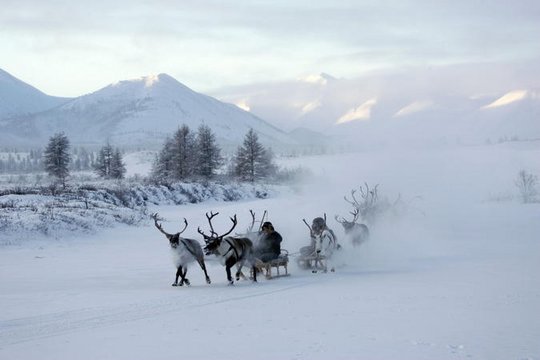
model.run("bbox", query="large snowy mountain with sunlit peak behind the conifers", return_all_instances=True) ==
[1,74,296,147]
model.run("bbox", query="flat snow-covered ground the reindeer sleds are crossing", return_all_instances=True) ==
[0,143,540,360]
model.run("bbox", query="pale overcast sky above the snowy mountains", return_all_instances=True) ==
[0,0,540,96]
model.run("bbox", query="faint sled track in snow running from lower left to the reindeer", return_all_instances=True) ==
[0,279,311,348]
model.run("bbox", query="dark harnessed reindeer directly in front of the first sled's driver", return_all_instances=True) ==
[197,212,257,285]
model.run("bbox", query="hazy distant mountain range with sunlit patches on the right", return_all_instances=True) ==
[214,65,540,143]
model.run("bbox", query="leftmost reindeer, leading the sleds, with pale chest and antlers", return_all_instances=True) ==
[150,213,211,286]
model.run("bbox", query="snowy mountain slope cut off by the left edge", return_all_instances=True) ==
[0,69,69,122]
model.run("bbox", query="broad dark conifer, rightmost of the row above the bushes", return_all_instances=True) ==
[233,129,275,182]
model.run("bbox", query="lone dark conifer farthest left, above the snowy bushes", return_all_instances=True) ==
[43,132,71,188]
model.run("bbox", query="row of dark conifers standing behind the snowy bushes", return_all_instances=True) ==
[38,124,277,187]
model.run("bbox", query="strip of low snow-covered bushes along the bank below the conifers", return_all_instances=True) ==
[0,182,277,243]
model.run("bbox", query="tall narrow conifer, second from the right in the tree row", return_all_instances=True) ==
[195,125,223,179]
